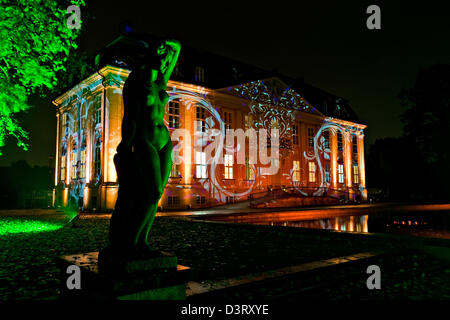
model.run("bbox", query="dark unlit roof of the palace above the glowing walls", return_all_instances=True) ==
[96,33,363,123]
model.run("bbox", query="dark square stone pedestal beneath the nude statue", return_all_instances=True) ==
[57,252,190,300]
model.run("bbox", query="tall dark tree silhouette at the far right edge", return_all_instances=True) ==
[400,64,450,199]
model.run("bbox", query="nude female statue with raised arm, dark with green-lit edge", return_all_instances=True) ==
[109,40,180,255]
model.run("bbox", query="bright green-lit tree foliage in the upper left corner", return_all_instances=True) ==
[0,0,85,155]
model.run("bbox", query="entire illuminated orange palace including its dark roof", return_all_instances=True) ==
[53,36,367,211]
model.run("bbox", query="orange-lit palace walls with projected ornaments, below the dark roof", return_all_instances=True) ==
[54,66,366,210]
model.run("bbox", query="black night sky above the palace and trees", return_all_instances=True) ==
[0,0,450,165]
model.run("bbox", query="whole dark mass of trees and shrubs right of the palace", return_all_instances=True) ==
[368,64,450,200]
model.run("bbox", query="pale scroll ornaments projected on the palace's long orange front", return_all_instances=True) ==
[166,82,357,202]
